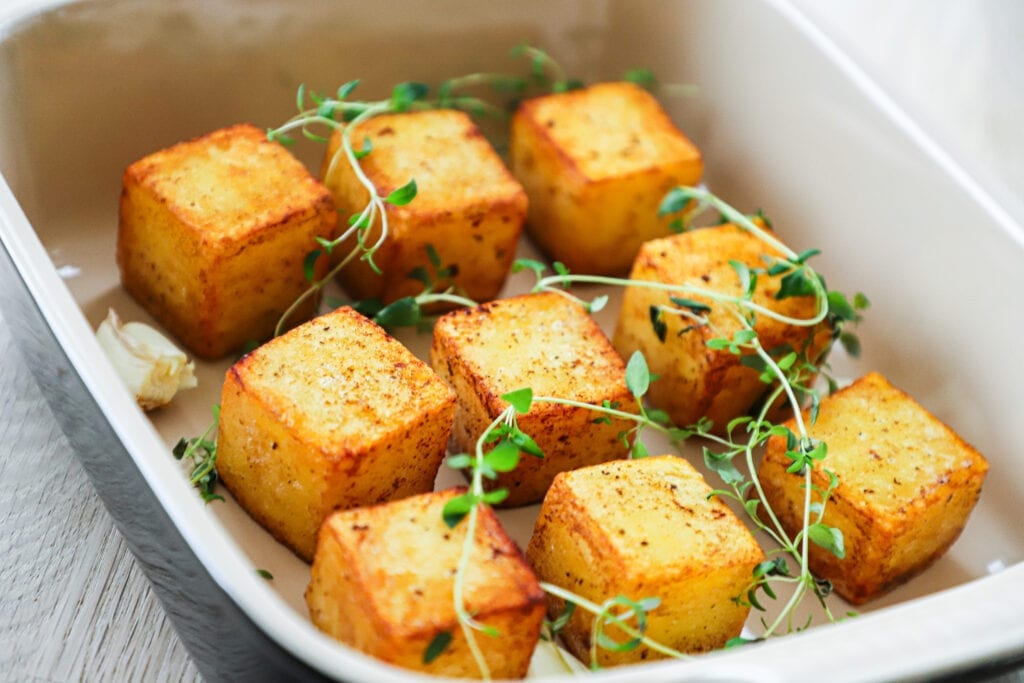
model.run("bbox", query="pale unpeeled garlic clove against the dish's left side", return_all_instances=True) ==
[96,308,197,411]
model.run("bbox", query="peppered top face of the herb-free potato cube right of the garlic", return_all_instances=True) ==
[234,307,455,454]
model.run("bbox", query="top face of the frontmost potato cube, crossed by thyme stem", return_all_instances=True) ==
[321,489,544,638]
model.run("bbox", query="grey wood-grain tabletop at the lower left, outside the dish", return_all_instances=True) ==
[0,314,201,681]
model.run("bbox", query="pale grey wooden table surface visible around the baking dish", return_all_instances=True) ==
[0,0,1024,682]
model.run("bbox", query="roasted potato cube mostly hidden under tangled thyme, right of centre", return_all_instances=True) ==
[613,223,831,432]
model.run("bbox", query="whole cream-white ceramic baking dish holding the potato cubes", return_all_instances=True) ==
[0,0,1024,681]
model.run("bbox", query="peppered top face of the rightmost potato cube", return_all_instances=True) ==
[769,373,988,519]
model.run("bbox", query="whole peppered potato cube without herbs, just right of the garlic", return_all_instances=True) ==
[217,308,455,561]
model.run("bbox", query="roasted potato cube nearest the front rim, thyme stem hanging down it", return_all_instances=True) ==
[306,489,544,679]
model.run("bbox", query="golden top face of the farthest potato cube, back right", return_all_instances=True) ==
[517,83,700,180]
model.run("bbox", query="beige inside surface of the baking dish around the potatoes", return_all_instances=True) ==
[0,0,1024,675]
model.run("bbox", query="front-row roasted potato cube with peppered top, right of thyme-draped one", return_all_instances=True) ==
[526,456,764,666]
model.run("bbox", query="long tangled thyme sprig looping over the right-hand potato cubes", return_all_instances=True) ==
[514,187,868,637]
